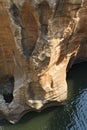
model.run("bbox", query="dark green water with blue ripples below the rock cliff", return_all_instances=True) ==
[0,63,87,130]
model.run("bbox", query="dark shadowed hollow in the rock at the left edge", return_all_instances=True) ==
[0,76,14,103]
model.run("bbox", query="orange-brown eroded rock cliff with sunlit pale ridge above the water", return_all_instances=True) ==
[0,0,87,123]
